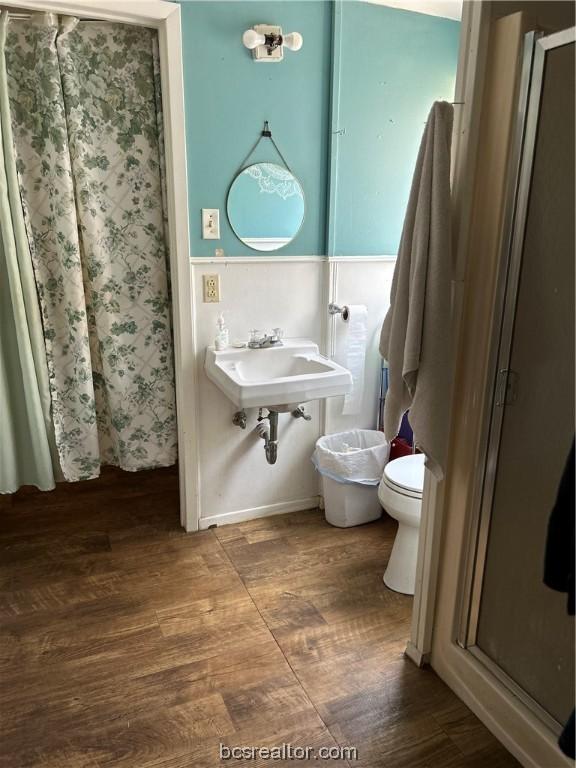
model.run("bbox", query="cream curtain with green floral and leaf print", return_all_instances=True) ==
[0,14,177,481]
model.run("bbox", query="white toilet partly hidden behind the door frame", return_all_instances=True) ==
[378,453,426,595]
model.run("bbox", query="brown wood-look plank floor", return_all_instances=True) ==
[0,470,517,768]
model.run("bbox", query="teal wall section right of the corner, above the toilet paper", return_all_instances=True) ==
[333,0,460,256]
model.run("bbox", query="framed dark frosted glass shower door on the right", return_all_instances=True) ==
[462,29,575,730]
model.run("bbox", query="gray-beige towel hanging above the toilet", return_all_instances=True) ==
[380,101,454,480]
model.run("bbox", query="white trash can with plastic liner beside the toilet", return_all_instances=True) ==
[312,429,390,528]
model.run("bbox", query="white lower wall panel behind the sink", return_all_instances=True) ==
[192,258,327,528]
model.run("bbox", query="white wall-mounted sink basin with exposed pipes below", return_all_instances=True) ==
[204,339,352,411]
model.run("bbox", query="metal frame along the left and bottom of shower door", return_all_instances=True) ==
[456,27,576,732]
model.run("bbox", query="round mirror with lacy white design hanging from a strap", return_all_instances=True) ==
[227,163,304,251]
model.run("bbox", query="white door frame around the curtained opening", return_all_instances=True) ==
[1,0,200,531]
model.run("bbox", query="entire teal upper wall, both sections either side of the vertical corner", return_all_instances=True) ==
[181,0,460,257]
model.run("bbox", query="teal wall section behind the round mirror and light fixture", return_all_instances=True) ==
[181,0,332,256]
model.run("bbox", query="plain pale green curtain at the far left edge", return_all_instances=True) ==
[0,16,58,493]
